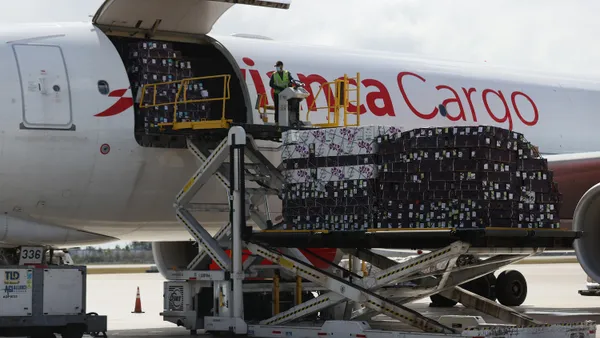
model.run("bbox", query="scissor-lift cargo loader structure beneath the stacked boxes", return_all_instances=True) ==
[161,126,596,338]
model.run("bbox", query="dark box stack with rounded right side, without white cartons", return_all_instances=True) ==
[376,126,560,228]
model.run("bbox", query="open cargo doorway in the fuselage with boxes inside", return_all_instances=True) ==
[111,36,246,148]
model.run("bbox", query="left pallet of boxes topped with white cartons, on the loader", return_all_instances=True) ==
[282,126,399,231]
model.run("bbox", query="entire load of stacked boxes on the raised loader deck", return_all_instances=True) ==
[282,126,560,231]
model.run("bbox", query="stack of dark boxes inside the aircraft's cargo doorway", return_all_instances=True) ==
[127,41,210,132]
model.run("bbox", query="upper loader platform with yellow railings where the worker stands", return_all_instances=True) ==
[136,69,360,148]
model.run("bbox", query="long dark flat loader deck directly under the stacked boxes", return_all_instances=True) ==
[244,228,582,250]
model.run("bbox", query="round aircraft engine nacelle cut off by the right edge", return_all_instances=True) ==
[573,183,600,282]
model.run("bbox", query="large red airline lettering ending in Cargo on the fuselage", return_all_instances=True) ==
[242,57,540,130]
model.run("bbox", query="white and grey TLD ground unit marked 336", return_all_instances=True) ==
[0,264,107,338]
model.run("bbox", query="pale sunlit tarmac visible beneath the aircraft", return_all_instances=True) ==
[87,263,600,338]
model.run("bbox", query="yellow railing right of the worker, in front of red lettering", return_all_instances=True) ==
[306,73,360,128]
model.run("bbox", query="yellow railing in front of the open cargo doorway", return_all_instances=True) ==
[140,74,233,130]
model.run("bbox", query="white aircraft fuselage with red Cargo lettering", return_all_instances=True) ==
[0,22,600,244]
